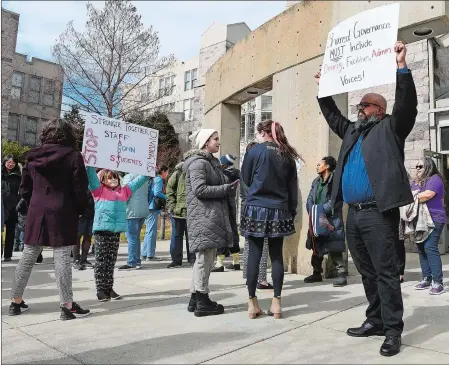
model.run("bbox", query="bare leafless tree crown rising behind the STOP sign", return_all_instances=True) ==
[53,0,173,117]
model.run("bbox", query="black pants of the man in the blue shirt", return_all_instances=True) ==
[346,207,404,336]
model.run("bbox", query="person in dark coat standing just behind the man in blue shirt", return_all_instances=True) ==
[304,156,347,287]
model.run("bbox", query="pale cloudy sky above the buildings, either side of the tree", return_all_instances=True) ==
[2,0,285,60]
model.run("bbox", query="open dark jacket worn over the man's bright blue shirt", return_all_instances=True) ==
[318,72,418,212]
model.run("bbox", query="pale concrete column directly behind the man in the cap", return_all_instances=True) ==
[272,58,347,275]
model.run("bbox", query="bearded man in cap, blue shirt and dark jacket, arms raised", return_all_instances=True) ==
[315,41,418,356]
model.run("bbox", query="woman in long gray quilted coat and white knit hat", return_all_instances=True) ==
[182,129,238,317]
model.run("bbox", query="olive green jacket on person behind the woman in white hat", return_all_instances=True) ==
[165,162,187,219]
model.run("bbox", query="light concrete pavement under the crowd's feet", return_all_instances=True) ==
[1,242,449,364]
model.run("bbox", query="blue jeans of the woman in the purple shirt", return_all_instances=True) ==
[417,222,444,284]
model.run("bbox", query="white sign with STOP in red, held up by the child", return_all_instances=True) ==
[81,113,159,177]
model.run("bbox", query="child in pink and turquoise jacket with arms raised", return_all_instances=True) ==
[86,167,148,302]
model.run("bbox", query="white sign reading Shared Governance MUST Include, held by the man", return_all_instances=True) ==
[318,3,399,98]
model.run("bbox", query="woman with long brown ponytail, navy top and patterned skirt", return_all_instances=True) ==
[240,120,301,318]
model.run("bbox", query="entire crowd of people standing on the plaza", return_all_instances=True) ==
[2,42,446,356]
